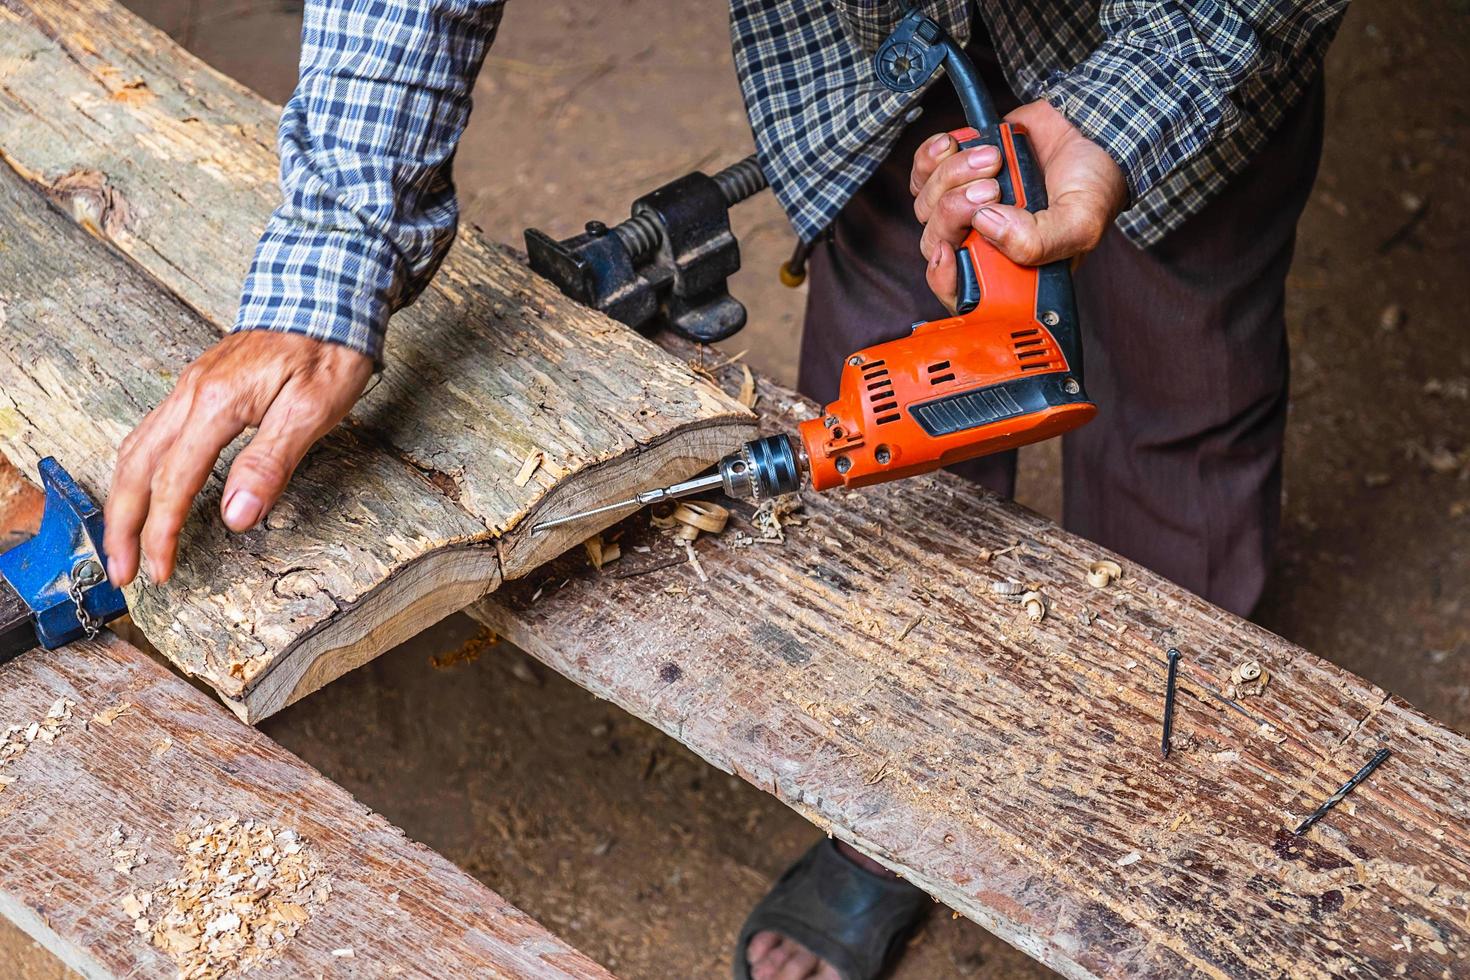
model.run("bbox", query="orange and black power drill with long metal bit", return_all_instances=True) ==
[535,10,1097,530]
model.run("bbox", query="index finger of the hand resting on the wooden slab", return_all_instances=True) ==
[141,379,257,582]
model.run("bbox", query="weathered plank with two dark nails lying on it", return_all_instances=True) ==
[475,357,1470,980]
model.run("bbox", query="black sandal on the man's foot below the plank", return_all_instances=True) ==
[734,837,933,980]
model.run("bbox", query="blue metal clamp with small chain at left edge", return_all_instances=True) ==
[0,457,128,661]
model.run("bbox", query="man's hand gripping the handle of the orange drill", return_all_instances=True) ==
[910,101,1127,310]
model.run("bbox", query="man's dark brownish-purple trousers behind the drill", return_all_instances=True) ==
[797,38,1323,616]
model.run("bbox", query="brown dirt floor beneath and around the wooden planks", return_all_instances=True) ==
[2,0,1470,980]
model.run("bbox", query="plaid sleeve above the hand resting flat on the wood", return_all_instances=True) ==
[234,0,503,363]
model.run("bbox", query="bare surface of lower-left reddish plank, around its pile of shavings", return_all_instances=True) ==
[0,633,610,980]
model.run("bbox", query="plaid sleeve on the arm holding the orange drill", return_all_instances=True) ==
[1042,0,1347,200]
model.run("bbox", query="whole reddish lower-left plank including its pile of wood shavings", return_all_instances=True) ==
[0,633,609,980]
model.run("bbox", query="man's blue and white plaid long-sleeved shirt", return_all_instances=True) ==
[235,0,1347,361]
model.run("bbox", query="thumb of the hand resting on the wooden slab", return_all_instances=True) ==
[219,382,338,533]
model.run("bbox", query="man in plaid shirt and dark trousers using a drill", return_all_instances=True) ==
[106,0,1345,980]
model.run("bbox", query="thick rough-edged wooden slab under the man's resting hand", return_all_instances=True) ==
[0,0,750,720]
